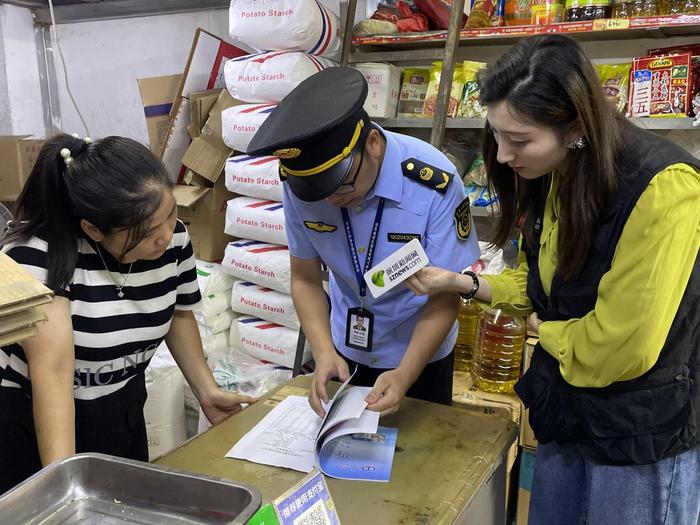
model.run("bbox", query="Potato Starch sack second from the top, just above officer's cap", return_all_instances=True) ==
[224,51,336,103]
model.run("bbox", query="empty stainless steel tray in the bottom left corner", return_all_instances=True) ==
[0,454,261,525]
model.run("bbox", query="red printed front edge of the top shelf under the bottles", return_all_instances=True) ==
[350,15,700,62]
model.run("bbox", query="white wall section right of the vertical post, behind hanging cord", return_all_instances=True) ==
[54,9,228,143]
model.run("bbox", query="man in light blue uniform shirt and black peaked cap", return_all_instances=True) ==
[248,67,479,415]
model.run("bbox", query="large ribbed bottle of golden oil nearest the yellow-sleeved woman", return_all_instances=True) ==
[472,309,527,394]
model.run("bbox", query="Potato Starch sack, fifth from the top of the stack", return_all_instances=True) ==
[224,197,287,245]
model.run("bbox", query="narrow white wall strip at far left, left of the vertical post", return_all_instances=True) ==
[0,5,46,137]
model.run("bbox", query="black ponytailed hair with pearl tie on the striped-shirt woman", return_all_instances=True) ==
[3,134,172,289]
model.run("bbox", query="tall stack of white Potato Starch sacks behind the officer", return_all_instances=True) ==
[217,0,340,368]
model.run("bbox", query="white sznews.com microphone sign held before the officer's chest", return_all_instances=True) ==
[364,239,430,298]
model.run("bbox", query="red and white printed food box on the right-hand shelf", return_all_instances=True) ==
[629,53,691,118]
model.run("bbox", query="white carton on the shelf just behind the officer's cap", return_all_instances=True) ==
[355,62,401,118]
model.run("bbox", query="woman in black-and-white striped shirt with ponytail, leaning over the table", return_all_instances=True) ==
[0,135,254,493]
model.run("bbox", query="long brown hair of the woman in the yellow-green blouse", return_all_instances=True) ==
[478,35,624,278]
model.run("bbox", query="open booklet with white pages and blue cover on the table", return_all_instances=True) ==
[226,379,398,482]
